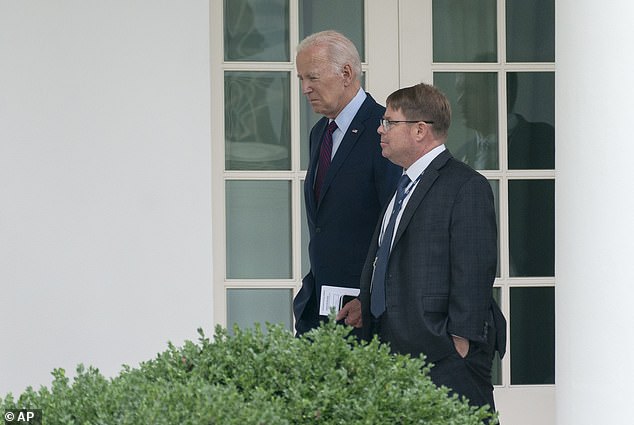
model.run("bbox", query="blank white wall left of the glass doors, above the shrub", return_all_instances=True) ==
[0,0,213,396]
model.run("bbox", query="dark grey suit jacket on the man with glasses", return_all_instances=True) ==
[360,150,506,362]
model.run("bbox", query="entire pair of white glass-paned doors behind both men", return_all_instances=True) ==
[210,0,556,425]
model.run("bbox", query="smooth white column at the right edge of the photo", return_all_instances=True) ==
[556,0,634,425]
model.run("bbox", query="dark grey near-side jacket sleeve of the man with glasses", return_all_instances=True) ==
[448,175,497,342]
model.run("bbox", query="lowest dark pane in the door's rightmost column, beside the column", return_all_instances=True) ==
[510,287,555,385]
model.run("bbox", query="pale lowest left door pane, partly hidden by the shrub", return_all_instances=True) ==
[227,289,293,330]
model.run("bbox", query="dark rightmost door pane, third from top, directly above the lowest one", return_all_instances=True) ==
[509,180,555,277]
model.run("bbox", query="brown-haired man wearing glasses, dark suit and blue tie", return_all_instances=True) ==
[340,84,506,409]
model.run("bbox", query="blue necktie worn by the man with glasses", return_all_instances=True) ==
[370,174,411,317]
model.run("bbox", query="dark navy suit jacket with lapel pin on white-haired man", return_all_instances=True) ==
[293,94,401,334]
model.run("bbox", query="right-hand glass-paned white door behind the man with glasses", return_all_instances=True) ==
[427,0,556,424]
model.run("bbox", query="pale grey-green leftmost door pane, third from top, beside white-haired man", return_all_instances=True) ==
[226,180,292,279]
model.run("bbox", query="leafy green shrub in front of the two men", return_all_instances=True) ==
[0,324,496,425]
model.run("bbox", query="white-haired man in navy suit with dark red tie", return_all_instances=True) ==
[293,31,400,334]
